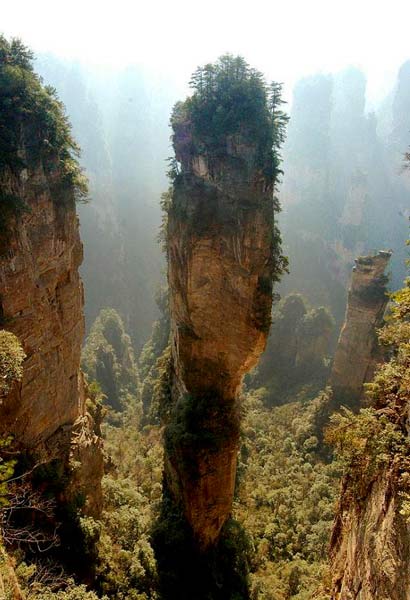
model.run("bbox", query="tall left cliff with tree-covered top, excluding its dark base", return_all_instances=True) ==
[0,36,102,515]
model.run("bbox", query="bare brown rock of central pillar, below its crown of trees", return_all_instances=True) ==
[165,120,274,548]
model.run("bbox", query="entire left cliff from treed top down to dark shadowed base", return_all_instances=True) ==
[0,36,103,594]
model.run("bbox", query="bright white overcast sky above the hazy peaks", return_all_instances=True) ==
[0,0,410,102]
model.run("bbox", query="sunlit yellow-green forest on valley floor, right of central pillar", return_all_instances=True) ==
[234,389,338,600]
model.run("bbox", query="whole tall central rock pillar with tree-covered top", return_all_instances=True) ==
[155,56,284,597]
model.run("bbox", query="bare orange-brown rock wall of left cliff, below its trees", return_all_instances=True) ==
[0,168,103,514]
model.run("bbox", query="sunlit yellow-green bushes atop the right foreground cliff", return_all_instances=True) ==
[326,272,410,497]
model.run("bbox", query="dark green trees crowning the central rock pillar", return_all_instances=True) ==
[171,54,288,181]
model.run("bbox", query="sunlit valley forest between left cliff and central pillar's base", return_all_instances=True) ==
[97,412,162,600]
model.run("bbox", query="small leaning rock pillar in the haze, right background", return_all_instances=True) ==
[329,251,391,406]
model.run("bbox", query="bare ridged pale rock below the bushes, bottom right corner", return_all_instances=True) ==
[330,469,410,600]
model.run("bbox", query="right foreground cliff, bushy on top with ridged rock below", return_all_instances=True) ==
[330,283,410,600]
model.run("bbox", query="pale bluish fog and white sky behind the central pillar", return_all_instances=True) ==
[0,0,410,347]
